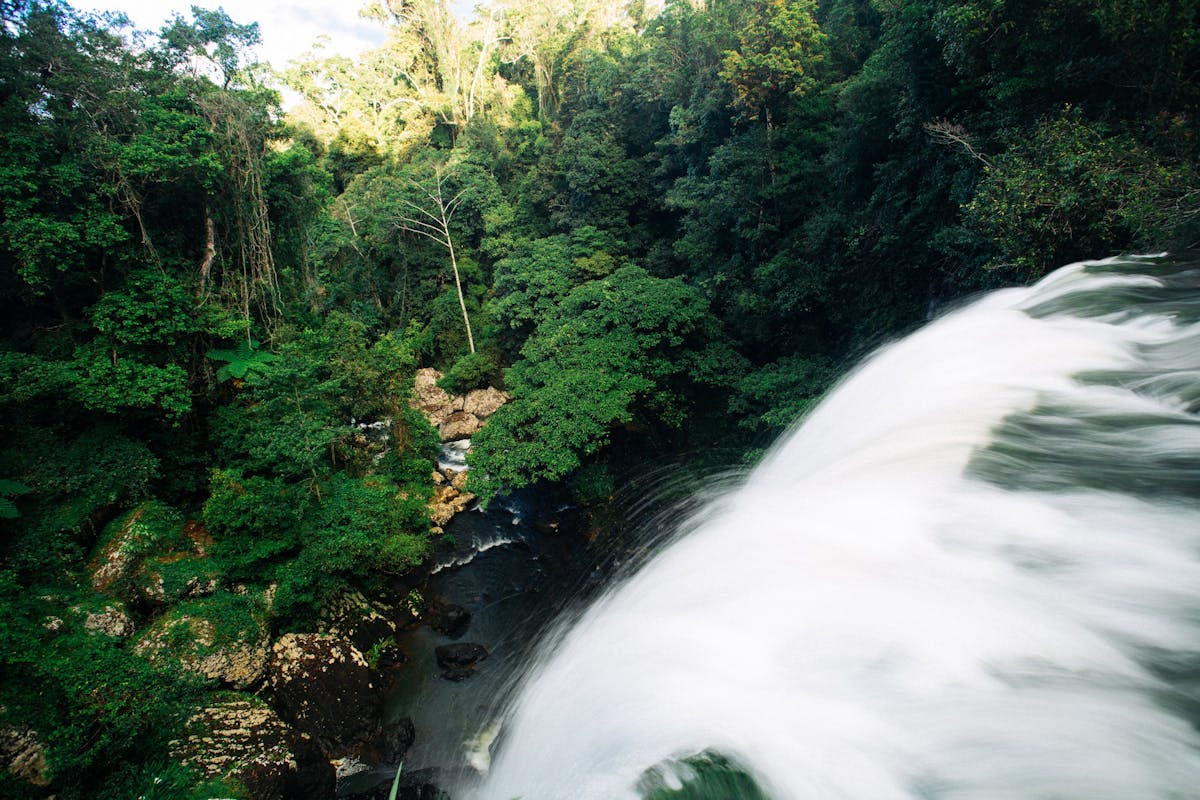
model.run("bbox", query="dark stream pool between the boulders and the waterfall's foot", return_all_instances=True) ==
[340,492,617,794]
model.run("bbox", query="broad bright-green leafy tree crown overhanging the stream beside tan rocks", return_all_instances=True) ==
[470,266,742,498]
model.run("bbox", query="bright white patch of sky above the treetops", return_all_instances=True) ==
[68,0,474,68]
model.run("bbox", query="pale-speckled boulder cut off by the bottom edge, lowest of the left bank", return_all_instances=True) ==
[170,694,335,800]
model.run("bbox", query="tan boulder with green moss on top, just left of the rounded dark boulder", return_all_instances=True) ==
[134,591,270,688]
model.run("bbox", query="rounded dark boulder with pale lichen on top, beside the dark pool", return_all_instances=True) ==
[269,633,380,758]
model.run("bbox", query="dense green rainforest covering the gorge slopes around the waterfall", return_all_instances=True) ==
[0,0,1200,798]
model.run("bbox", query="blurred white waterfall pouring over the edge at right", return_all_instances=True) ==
[456,259,1200,800]
